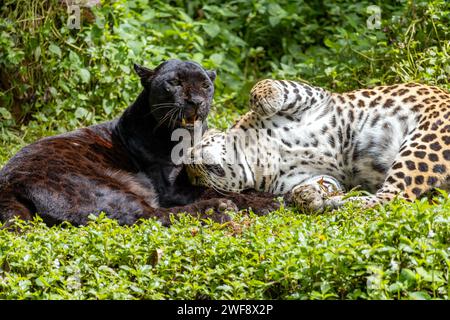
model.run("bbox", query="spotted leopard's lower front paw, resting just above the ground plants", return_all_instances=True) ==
[291,184,328,212]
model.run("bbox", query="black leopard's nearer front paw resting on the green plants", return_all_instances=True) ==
[197,198,238,223]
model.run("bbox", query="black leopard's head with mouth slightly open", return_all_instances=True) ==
[134,59,216,129]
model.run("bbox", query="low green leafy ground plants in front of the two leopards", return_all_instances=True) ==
[0,196,450,299]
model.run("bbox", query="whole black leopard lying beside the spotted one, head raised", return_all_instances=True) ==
[0,60,276,226]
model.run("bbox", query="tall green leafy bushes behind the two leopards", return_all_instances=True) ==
[0,0,450,131]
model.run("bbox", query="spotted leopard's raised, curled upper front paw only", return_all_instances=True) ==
[250,79,284,117]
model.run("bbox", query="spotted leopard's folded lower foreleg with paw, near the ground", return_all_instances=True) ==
[291,175,343,212]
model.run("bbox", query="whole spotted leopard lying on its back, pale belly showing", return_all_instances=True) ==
[188,80,450,211]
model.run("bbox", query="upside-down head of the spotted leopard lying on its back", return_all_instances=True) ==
[186,130,252,192]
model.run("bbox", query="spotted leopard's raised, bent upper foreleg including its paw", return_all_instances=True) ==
[250,79,330,117]
